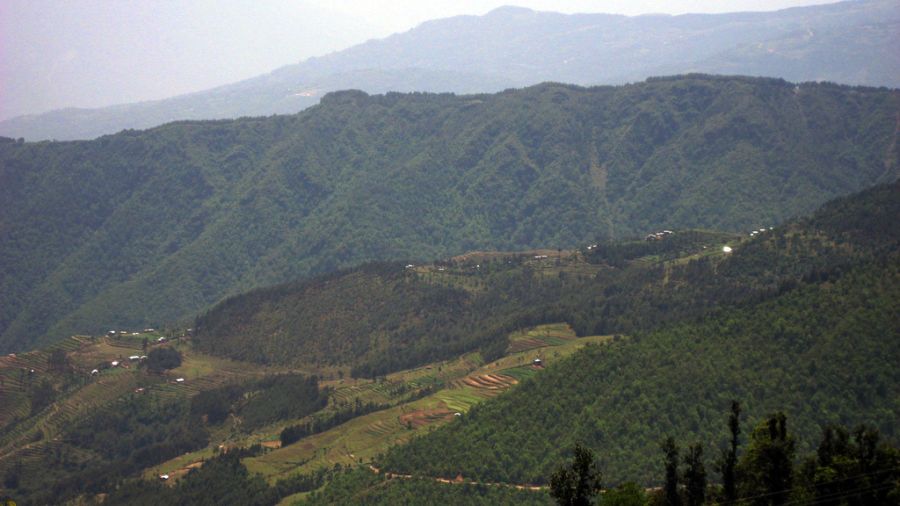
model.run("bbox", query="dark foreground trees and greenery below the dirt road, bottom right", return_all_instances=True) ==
[306,418,900,506]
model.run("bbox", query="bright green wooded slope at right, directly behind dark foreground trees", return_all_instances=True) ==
[379,183,900,484]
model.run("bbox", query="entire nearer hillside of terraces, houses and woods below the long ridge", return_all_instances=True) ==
[0,176,900,505]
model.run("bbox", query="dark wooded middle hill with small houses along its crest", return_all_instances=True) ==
[194,182,900,377]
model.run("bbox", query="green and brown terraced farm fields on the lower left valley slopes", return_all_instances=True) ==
[0,324,607,494]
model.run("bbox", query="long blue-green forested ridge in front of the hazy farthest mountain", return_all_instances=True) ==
[0,76,900,349]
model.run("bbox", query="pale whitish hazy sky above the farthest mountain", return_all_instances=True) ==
[0,0,834,119]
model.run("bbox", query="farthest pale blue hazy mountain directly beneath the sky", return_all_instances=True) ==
[0,0,900,140]
